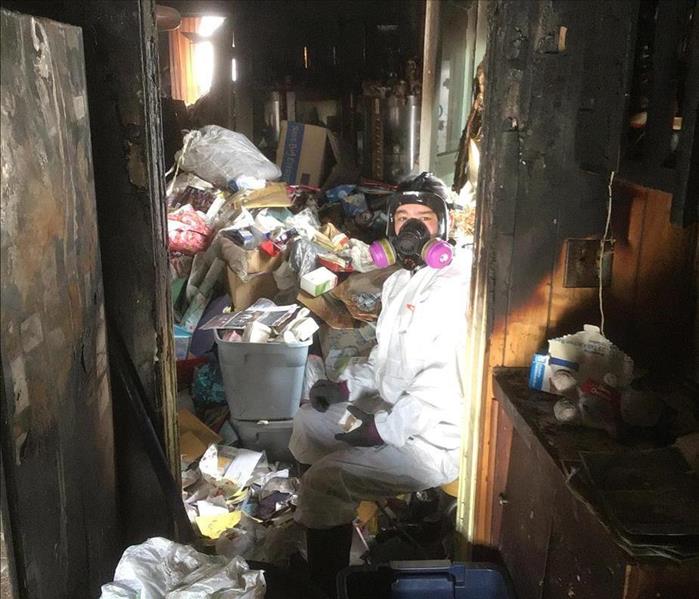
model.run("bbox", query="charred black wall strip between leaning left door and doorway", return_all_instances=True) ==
[3,0,179,547]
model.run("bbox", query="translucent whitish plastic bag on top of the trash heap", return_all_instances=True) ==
[177,125,282,189]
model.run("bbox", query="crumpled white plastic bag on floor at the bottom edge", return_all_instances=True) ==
[100,537,266,599]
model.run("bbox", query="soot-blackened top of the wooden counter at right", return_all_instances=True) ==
[494,368,699,569]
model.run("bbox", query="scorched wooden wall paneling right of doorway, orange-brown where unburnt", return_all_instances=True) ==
[475,0,696,545]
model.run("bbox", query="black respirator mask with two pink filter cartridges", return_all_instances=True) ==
[369,191,454,270]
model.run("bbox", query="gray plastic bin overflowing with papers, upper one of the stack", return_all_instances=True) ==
[215,331,312,422]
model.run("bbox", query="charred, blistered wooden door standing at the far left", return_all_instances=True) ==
[0,10,118,599]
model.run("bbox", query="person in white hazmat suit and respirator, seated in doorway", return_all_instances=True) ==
[289,173,471,596]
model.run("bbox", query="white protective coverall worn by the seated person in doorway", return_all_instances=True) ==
[289,250,471,528]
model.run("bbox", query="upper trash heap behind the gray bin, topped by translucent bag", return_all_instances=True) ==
[167,125,469,357]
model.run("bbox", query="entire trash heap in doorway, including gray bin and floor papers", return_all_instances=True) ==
[166,125,473,565]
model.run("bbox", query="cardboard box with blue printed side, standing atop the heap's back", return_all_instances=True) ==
[277,121,329,187]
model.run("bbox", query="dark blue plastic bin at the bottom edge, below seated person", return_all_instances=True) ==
[337,561,515,599]
